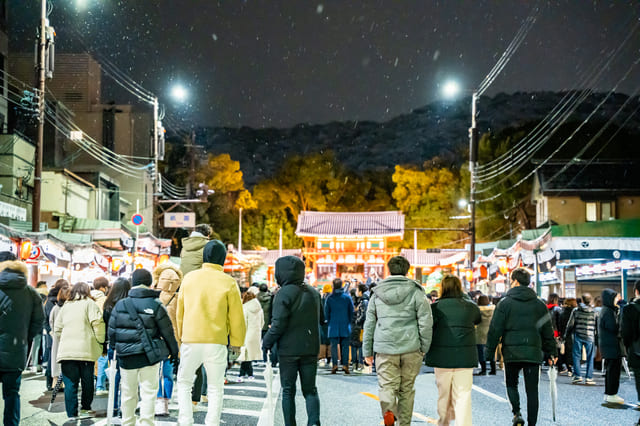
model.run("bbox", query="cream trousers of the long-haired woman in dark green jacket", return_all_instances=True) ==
[434,368,473,426]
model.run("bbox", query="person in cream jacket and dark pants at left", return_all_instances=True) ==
[53,282,105,418]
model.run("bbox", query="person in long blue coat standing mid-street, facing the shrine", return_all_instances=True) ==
[324,278,353,374]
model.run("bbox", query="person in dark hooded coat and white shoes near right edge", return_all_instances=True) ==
[598,288,624,405]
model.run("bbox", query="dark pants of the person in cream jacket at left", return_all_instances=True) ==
[60,361,94,417]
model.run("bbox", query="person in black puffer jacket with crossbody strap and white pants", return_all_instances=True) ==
[109,269,178,425]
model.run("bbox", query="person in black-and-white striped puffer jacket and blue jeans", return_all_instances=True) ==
[565,293,597,385]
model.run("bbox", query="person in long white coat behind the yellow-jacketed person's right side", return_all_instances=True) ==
[238,287,265,380]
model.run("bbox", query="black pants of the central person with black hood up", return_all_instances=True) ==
[280,355,320,426]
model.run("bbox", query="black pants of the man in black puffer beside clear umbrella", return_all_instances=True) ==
[504,362,540,426]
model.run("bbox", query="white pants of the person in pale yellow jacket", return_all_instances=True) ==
[178,343,227,426]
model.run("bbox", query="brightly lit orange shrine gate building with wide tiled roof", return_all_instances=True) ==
[296,211,404,282]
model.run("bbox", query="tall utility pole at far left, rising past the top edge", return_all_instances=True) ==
[31,0,47,232]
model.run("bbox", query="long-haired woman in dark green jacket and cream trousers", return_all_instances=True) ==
[427,275,481,426]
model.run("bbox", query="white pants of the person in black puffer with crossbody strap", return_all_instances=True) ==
[120,363,160,426]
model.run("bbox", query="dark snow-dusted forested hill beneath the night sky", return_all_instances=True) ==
[198,92,640,187]
